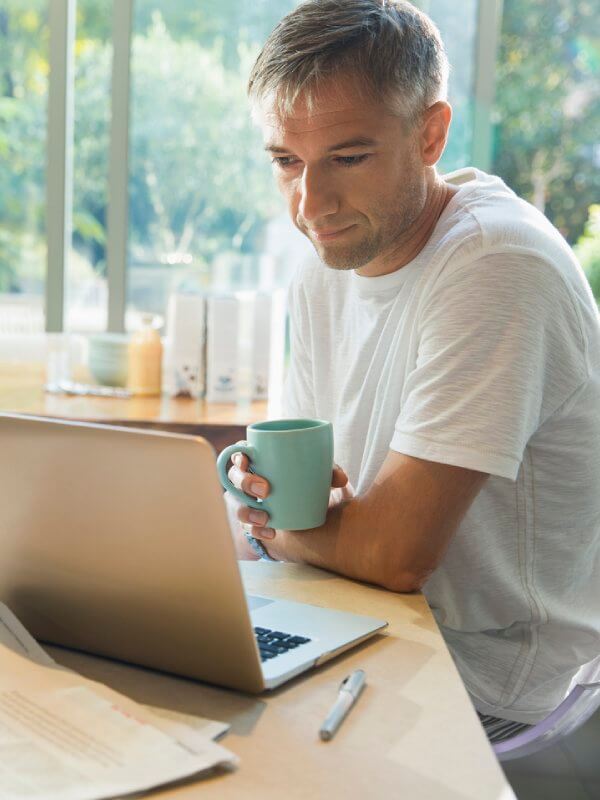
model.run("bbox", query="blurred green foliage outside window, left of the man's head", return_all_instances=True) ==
[0,0,296,293]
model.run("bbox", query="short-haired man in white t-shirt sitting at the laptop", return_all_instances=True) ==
[224,0,600,734]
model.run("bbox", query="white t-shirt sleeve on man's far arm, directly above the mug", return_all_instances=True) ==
[283,278,317,419]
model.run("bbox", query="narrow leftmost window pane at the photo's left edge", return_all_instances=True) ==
[0,0,49,333]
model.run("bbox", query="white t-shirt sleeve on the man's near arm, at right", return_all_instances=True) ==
[390,254,587,480]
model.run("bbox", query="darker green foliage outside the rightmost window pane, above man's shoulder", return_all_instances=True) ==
[494,0,600,250]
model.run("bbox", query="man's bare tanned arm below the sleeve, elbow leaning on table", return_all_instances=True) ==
[238,451,488,592]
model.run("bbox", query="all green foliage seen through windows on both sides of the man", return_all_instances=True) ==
[0,0,600,296]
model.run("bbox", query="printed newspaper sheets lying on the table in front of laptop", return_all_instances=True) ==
[0,604,237,800]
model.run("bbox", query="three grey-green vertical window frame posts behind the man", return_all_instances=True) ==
[45,0,503,332]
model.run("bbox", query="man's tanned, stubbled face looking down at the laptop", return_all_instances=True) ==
[261,79,426,274]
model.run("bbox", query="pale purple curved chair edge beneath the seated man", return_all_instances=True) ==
[492,680,600,761]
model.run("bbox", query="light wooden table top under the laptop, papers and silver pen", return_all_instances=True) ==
[49,562,514,800]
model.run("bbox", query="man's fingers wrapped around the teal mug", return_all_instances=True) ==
[226,453,354,559]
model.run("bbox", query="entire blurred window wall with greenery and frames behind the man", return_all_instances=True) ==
[0,0,600,334]
